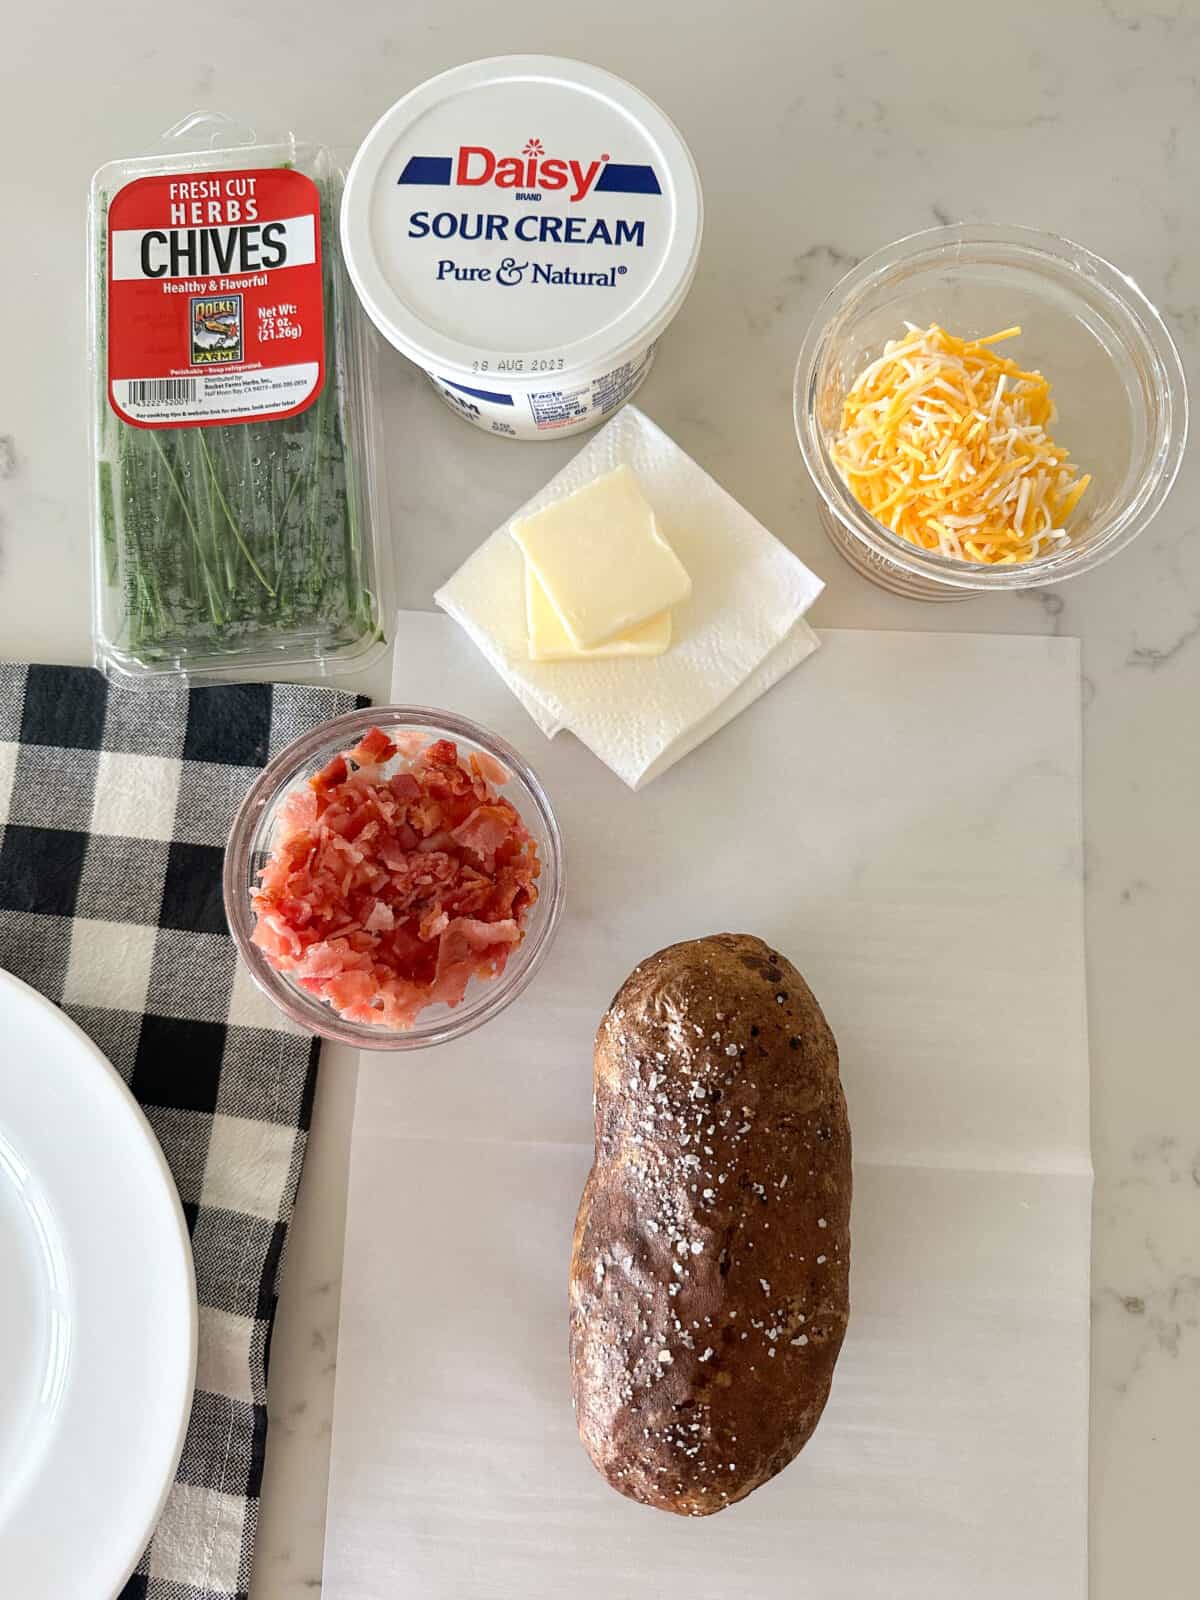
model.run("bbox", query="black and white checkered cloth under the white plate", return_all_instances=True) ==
[0,662,366,1600]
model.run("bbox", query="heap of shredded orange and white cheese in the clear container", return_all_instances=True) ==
[832,323,1091,566]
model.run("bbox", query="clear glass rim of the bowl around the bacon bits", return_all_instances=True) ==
[222,706,565,1050]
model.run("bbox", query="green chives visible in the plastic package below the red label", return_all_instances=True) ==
[96,176,378,667]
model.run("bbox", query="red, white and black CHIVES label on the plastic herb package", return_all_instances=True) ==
[107,166,325,427]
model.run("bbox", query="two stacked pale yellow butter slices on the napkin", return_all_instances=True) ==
[512,467,691,650]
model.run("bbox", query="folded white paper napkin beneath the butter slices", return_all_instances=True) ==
[434,405,824,789]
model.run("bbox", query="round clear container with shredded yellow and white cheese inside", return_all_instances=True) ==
[795,224,1187,600]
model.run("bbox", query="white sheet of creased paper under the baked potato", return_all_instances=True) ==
[325,613,1091,1600]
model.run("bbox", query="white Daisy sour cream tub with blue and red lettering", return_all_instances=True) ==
[341,56,704,438]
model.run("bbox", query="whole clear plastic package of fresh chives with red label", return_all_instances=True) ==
[88,114,389,677]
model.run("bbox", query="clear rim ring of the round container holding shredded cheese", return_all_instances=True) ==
[794,222,1187,592]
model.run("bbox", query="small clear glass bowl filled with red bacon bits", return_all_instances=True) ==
[224,706,563,1050]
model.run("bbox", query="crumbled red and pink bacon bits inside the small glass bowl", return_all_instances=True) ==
[253,728,541,1029]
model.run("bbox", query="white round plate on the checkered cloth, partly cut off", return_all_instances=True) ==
[0,973,195,1600]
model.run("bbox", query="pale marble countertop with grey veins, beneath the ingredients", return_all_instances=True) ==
[0,0,1200,1600]
